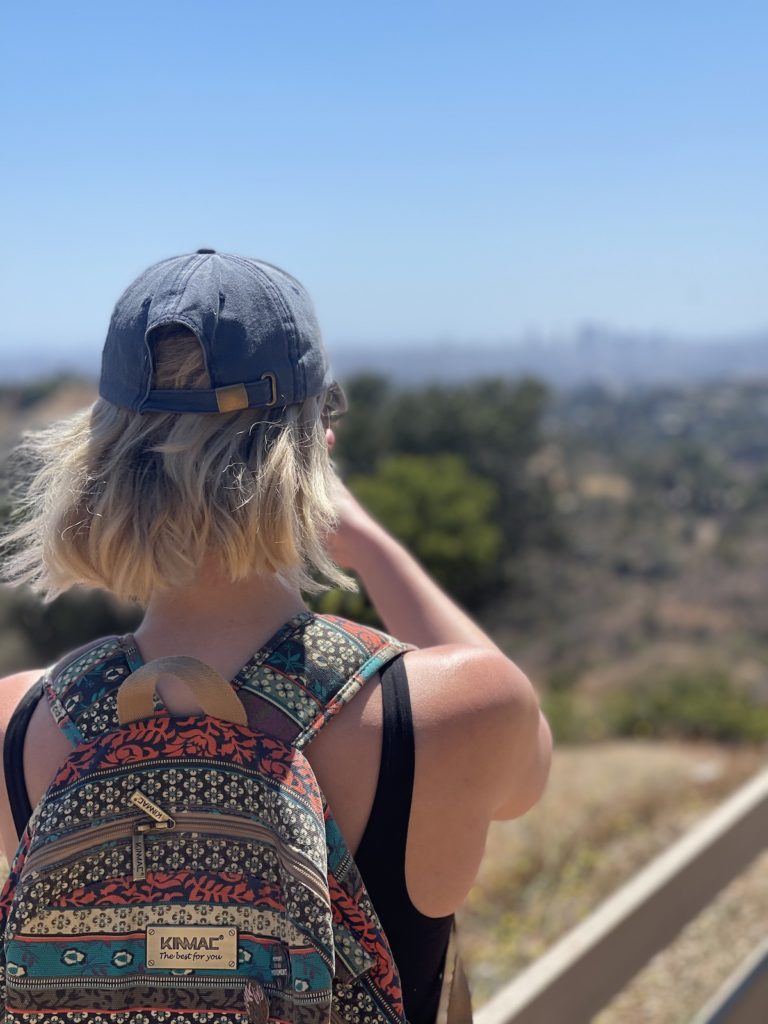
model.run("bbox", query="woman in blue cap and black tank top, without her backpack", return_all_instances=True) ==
[0,250,550,1024]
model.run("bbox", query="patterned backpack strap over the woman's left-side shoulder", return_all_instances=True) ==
[43,636,141,744]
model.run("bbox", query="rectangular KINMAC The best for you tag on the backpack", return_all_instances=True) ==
[146,925,238,971]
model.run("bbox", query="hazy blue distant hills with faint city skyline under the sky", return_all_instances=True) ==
[0,328,768,389]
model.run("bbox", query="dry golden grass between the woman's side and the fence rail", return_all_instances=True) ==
[461,741,768,1007]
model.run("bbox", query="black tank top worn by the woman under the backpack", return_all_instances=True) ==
[3,655,454,1024]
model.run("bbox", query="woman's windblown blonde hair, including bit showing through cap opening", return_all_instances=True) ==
[2,328,354,603]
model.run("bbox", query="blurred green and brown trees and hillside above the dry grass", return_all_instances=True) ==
[0,374,768,742]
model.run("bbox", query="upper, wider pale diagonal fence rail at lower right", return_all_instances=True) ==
[475,769,768,1024]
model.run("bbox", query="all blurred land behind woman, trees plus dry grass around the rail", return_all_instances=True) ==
[0,374,768,1024]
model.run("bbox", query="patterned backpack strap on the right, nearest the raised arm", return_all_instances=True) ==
[234,615,412,750]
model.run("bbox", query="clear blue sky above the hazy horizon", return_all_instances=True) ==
[0,0,768,354]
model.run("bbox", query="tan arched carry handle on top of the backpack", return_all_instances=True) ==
[118,654,248,725]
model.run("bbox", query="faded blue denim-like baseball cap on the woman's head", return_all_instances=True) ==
[99,249,344,413]
